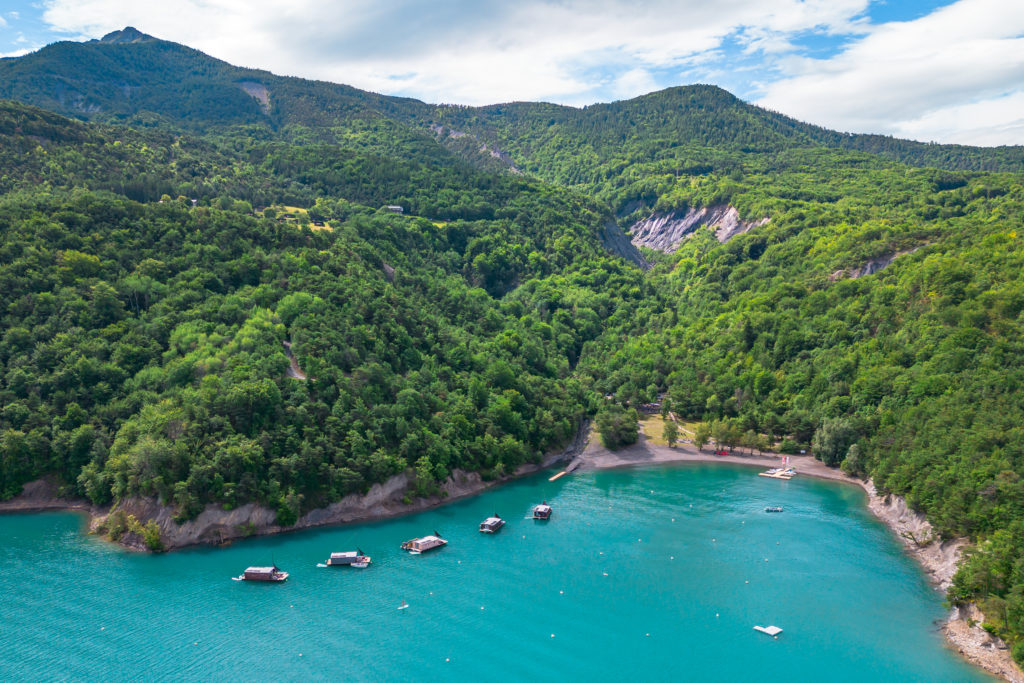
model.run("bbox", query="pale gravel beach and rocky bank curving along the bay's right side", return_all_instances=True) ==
[567,431,1024,683]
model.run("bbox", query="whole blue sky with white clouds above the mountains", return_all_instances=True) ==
[0,0,1024,145]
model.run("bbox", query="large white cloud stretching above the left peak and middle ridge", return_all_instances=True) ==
[44,0,868,104]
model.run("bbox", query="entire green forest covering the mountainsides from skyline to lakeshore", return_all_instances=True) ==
[6,29,1024,663]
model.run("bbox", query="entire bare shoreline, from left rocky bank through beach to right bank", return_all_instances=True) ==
[0,423,1024,683]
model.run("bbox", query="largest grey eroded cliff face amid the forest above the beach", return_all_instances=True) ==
[630,204,768,254]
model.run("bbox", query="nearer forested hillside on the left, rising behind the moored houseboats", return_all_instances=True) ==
[0,100,643,523]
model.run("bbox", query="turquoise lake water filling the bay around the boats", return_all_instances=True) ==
[0,465,990,683]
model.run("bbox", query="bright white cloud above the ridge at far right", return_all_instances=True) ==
[758,0,1024,144]
